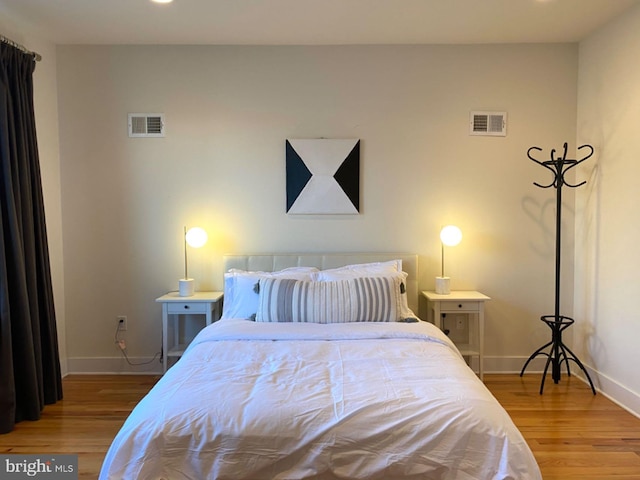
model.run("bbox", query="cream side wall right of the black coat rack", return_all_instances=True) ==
[575,2,640,415]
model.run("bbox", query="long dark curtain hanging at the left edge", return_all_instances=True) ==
[0,43,62,433]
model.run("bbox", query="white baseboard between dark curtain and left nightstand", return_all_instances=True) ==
[67,356,162,375]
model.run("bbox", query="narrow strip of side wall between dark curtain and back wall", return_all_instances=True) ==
[0,11,67,374]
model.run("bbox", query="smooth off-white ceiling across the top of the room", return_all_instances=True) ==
[0,0,640,45]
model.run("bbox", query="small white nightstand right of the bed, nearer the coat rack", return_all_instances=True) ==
[422,290,491,380]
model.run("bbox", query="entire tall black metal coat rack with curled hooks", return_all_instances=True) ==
[520,143,596,395]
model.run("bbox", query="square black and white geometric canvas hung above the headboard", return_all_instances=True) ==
[286,138,360,215]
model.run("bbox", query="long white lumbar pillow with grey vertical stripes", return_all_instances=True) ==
[256,277,401,323]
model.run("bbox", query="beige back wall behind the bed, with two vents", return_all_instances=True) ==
[58,45,578,371]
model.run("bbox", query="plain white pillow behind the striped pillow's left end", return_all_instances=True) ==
[222,267,318,318]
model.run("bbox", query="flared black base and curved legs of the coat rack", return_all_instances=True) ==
[520,315,596,395]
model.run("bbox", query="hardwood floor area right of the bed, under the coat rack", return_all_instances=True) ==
[485,374,640,480]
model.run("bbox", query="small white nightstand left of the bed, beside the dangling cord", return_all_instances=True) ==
[156,292,223,373]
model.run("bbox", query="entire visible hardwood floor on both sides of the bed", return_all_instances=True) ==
[0,374,640,480]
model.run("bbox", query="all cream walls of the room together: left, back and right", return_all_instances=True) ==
[0,0,640,413]
